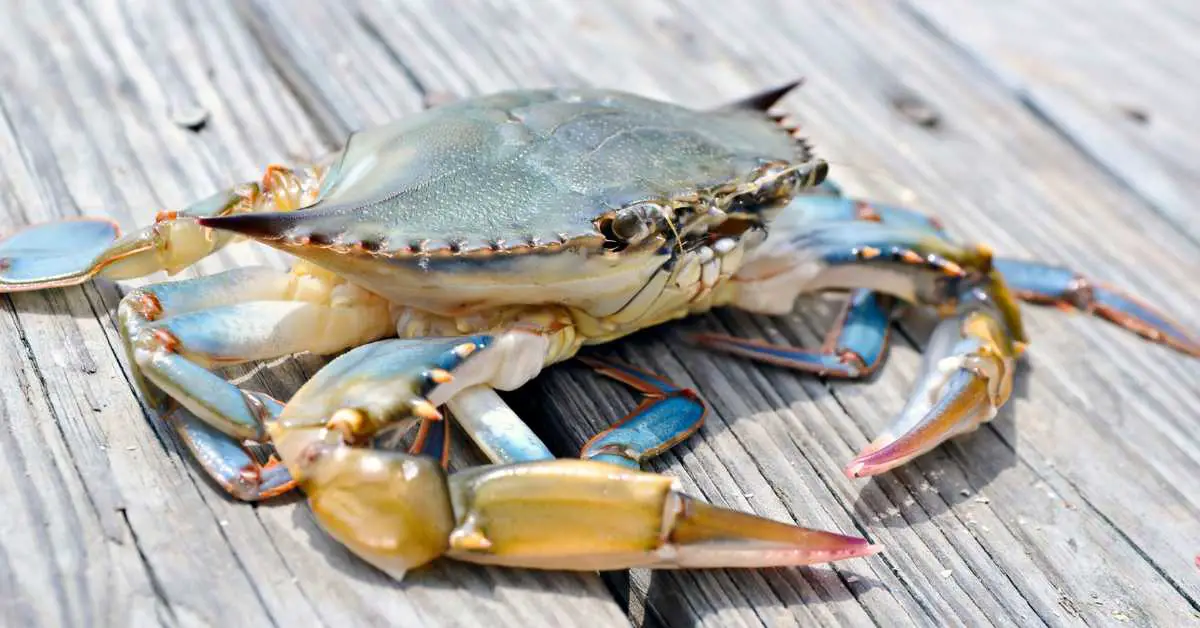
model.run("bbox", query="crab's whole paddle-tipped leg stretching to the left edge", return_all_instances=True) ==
[0,160,325,293]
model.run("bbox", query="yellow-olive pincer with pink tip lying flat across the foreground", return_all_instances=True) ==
[448,460,880,570]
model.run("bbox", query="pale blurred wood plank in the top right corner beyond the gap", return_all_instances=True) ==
[902,0,1200,241]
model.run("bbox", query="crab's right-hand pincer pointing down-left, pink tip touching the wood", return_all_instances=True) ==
[845,282,1024,478]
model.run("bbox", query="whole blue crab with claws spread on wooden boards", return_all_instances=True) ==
[0,84,1200,579]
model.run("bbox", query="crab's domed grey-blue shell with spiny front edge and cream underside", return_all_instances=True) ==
[203,89,826,327]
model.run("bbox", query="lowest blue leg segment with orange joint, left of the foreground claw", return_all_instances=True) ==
[164,393,295,502]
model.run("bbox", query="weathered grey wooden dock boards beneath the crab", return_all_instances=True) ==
[0,0,1200,628]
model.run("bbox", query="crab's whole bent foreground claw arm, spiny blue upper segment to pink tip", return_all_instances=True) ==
[268,331,878,579]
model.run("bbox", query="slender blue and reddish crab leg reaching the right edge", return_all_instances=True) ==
[992,259,1200,358]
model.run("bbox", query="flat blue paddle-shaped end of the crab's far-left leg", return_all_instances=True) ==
[0,219,120,293]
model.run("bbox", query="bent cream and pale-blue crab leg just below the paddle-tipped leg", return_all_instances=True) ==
[118,263,391,439]
